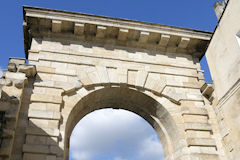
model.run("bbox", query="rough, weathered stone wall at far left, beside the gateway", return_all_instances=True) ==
[0,58,36,159]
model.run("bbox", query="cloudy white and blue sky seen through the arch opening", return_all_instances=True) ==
[70,109,163,160]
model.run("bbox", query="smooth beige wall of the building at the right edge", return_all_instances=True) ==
[206,0,240,159]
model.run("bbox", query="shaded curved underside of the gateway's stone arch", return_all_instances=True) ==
[64,87,183,160]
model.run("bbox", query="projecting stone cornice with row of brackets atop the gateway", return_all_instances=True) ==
[23,7,212,57]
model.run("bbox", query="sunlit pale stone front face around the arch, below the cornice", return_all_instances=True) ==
[18,35,224,159]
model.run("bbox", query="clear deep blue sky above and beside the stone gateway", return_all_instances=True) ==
[0,0,217,81]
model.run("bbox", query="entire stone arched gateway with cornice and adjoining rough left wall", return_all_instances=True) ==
[0,7,227,160]
